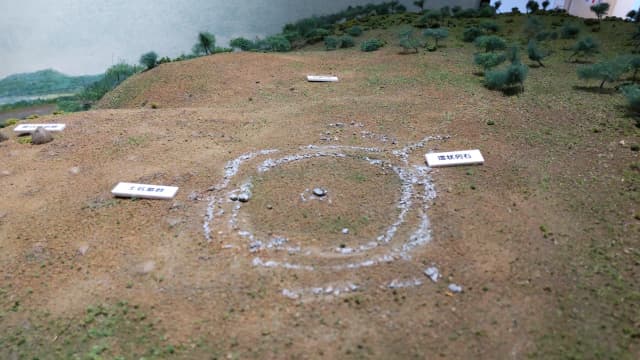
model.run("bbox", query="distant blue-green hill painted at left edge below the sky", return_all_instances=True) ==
[0,69,103,97]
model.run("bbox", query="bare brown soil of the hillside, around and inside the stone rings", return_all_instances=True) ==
[0,47,640,359]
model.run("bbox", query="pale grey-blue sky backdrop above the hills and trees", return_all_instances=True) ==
[0,0,640,79]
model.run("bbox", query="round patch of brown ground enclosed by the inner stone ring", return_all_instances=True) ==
[241,157,401,247]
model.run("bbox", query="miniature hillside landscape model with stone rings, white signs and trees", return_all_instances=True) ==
[0,1,640,359]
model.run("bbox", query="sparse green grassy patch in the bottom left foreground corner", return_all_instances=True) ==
[0,301,182,359]
